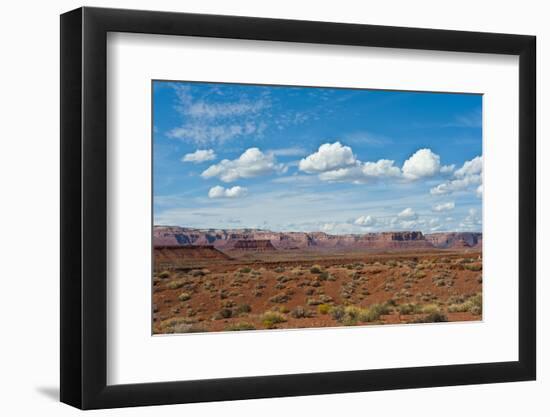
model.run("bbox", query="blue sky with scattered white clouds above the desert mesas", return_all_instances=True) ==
[153,81,482,234]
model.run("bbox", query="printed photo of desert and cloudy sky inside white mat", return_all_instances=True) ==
[152,80,483,334]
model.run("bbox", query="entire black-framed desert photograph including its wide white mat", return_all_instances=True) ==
[61,7,536,409]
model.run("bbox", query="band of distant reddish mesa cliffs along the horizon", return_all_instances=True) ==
[153,226,482,251]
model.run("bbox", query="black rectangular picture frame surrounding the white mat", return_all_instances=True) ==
[60,7,536,409]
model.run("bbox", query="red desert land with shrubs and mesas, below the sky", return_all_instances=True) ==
[152,226,482,334]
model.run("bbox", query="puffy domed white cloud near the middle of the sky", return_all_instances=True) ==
[299,142,357,174]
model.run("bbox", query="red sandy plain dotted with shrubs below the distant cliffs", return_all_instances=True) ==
[153,246,482,334]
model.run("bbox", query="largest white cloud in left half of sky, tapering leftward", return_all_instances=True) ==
[201,148,285,182]
